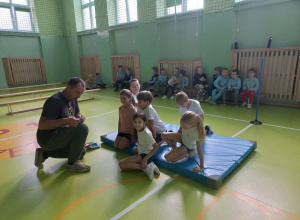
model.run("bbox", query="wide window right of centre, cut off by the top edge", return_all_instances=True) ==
[156,0,203,17]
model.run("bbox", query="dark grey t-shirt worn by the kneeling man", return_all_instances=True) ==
[37,91,79,142]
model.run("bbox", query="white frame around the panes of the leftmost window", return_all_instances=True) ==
[0,0,36,33]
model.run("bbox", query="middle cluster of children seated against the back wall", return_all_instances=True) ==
[141,67,189,99]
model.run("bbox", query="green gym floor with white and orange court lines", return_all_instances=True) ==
[0,88,300,220]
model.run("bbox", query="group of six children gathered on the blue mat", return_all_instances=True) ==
[114,79,213,180]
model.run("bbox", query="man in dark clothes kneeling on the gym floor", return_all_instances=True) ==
[34,77,91,172]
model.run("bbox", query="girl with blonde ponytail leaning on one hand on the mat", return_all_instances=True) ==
[162,111,205,172]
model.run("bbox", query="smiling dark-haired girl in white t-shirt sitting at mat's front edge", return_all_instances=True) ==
[119,112,160,180]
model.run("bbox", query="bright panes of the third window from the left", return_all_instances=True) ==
[116,0,137,24]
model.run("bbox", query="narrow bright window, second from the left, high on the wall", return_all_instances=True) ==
[81,0,97,30]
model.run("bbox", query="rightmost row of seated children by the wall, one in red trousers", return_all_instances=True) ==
[194,67,259,108]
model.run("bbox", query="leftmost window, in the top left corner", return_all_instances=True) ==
[0,0,34,32]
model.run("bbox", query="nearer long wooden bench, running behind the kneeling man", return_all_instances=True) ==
[0,89,101,115]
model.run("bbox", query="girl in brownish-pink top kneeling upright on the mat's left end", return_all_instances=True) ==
[114,89,136,150]
